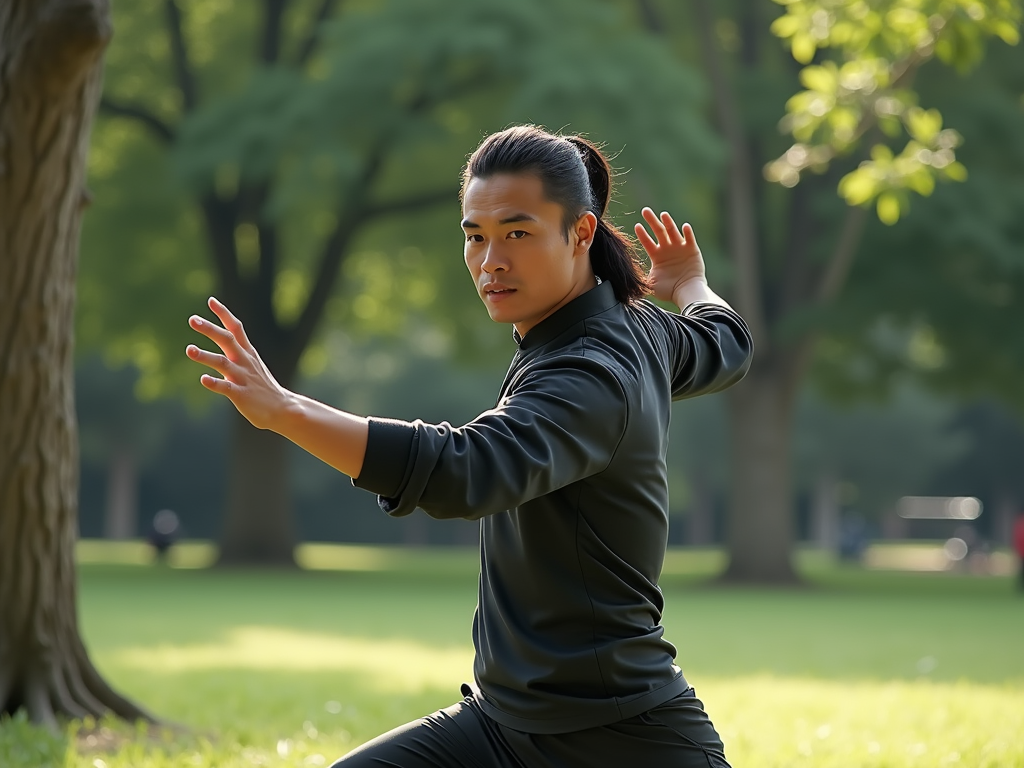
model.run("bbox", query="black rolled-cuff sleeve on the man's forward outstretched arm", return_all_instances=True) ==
[352,355,628,519]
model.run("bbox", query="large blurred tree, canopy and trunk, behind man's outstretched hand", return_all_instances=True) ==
[83,0,714,563]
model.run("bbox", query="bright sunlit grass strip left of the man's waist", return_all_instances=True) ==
[108,626,473,693]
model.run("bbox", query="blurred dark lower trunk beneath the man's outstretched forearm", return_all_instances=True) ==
[218,412,295,567]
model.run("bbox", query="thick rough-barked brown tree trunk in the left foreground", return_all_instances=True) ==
[0,0,148,727]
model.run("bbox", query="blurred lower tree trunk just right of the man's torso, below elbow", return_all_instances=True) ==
[723,361,799,584]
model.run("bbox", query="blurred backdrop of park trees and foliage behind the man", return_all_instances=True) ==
[76,0,1024,580]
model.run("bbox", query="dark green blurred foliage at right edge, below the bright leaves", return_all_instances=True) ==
[808,39,1024,413]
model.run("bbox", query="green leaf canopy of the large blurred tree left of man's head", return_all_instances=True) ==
[78,0,721,396]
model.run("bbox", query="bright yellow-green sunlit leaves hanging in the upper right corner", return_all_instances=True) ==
[765,0,1022,224]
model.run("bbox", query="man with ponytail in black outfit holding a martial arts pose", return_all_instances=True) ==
[186,126,753,768]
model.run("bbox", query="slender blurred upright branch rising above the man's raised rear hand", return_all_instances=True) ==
[692,0,769,348]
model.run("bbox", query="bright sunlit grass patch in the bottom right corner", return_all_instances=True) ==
[690,675,1024,768]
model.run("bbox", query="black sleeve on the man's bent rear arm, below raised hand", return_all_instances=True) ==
[659,301,754,400]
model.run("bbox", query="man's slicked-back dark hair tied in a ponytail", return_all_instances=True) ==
[459,125,650,303]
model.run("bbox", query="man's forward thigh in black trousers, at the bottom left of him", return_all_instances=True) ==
[332,697,523,768]
